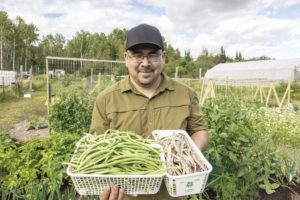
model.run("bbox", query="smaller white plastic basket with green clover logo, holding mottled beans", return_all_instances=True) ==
[152,130,212,197]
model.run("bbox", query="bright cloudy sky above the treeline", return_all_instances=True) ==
[0,0,300,60]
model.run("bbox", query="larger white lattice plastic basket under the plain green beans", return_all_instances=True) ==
[67,138,165,195]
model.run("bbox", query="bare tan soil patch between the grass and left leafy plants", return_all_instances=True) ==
[9,120,49,143]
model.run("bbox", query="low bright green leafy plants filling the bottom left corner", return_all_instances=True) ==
[0,132,81,199]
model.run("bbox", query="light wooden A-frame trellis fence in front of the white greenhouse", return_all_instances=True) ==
[199,79,291,109]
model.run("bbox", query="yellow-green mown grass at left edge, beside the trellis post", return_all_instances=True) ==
[0,79,47,132]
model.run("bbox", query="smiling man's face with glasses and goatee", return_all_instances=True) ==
[124,44,166,88]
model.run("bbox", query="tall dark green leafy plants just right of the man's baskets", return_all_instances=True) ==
[203,99,287,200]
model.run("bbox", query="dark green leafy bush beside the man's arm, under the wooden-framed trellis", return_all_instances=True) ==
[49,88,92,133]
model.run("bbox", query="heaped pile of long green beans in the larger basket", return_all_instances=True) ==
[71,130,166,175]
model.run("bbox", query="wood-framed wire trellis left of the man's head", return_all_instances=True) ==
[46,56,128,103]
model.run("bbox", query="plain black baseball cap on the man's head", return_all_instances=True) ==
[126,24,164,50]
